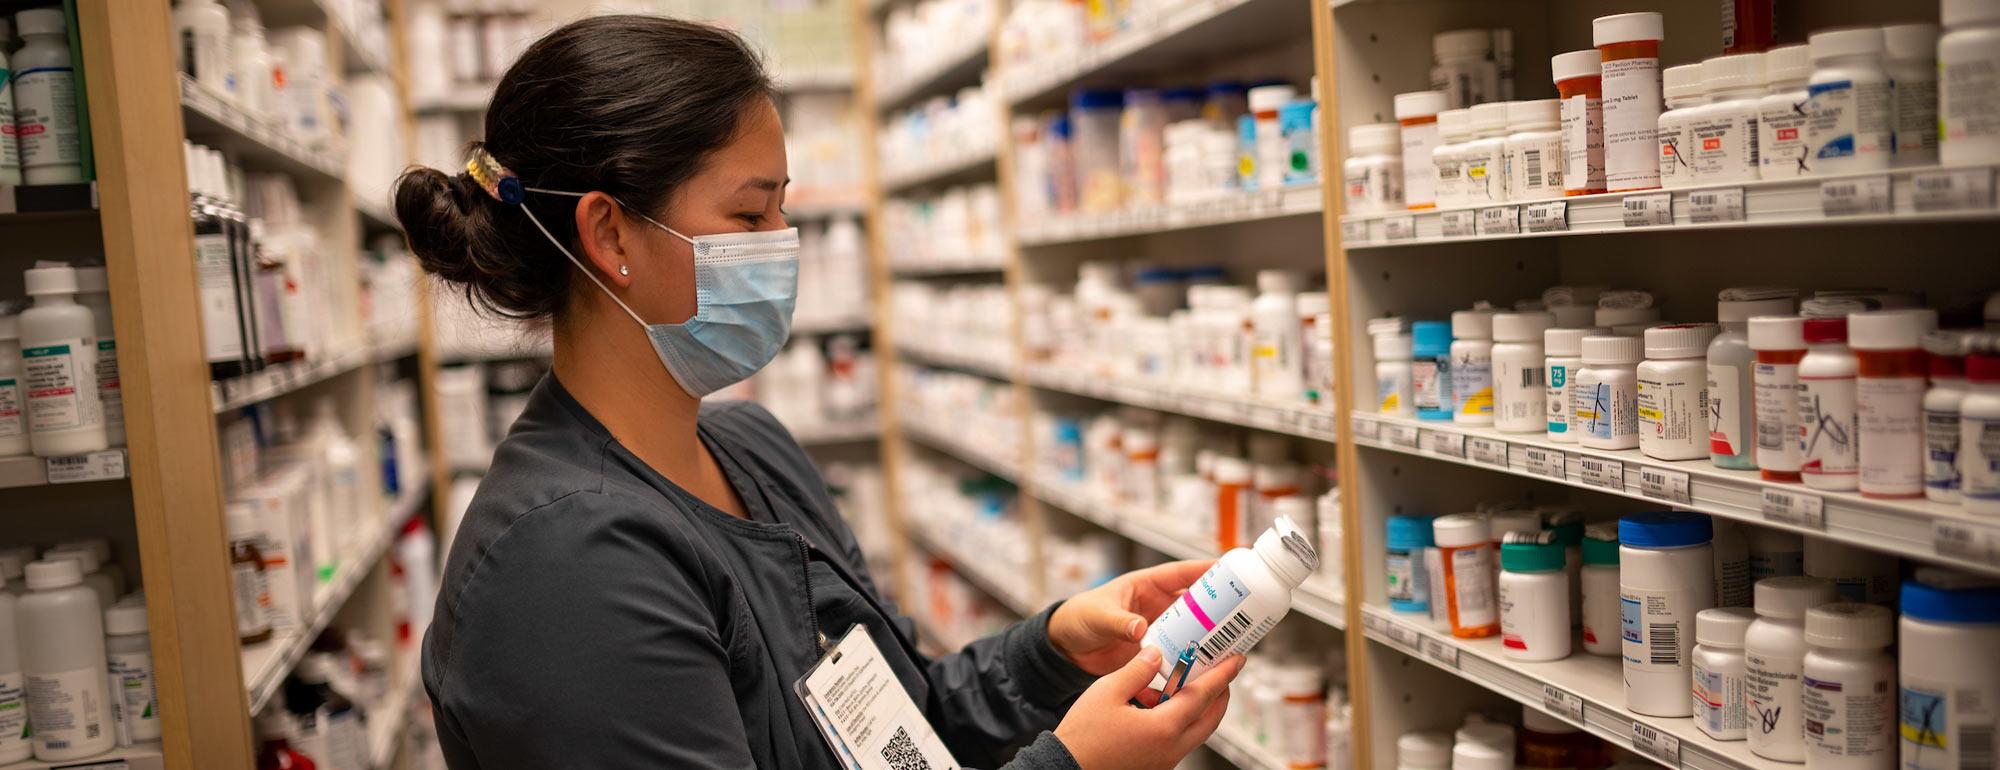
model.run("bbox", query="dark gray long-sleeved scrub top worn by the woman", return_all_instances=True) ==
[422,376,1092,770]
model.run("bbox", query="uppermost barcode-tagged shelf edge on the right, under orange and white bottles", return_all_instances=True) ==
[1340,166,2000,250]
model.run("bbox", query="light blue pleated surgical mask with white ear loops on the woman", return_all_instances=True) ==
[522,188,798,398]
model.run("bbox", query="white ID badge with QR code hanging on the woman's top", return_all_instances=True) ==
[792,624,958,770]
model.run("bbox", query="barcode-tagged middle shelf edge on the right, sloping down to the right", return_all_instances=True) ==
[1350,414,2000,574]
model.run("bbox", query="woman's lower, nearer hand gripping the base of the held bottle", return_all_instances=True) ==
[1056,648,1244,770]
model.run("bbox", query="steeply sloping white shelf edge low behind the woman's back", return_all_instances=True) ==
[242,474,430,716]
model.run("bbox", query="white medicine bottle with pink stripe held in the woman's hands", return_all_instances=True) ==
[1142,518,1320,694]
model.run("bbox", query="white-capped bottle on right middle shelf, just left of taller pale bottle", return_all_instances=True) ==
[1636,324,1718,460]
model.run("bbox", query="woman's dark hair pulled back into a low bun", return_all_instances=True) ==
[396,16,772,318]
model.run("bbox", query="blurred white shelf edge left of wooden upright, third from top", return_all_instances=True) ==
[1028,364,1338,442]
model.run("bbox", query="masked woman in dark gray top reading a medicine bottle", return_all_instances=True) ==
[396,16,1242,770]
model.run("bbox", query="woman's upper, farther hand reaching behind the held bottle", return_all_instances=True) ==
[1048,560,1214,676]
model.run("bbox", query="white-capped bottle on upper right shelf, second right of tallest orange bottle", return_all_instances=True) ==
[1686,54,1764,184]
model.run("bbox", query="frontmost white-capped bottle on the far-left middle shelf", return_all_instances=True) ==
[20,266,110,458]
